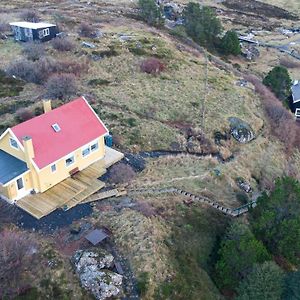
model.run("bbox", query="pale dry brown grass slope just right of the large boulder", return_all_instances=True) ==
[97,206,174,299]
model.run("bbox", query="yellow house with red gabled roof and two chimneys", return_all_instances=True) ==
[0,97,116,202]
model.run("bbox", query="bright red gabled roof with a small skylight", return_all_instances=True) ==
[12,97,108,169]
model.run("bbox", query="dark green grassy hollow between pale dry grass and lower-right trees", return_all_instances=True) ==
[156,206,229,300]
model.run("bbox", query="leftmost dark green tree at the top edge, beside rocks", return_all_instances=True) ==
[138,0,164,26]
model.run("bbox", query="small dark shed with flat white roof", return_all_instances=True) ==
[9,22,58,42]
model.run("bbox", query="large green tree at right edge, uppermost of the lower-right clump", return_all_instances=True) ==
[251,177,300,265]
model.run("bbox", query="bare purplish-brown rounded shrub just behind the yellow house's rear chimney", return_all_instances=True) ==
[46,73,77,99]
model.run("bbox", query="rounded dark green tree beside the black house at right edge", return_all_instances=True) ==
[263,66,292,101]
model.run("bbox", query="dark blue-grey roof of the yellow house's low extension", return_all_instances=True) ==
[0,150,28,184]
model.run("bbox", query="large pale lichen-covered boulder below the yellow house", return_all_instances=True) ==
[72,248,123,300]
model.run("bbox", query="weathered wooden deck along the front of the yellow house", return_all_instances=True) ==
[16,147,124,219]
